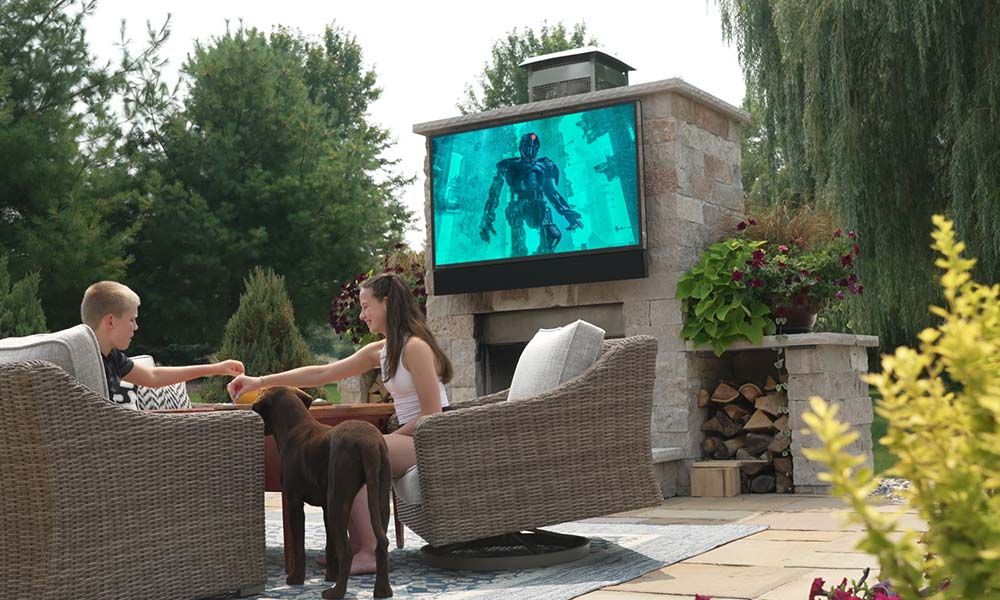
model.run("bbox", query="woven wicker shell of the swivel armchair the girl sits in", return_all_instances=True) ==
[396,336,662,547]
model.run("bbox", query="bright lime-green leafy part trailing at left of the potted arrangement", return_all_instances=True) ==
[677,238,774,356]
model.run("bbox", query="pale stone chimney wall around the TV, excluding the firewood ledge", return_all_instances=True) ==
[402,79,748,491]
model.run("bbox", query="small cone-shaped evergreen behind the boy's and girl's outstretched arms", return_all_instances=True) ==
[202,267,321,402]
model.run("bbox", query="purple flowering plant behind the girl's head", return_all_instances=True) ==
[330,244,427,346]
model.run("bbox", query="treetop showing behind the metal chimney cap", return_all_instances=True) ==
[458,21,597,115]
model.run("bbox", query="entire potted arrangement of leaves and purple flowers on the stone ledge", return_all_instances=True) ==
[677,209,864,355]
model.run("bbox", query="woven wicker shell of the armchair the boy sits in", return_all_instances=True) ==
[0,361,266,600]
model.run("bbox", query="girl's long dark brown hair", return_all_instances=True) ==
[361,273,454,383]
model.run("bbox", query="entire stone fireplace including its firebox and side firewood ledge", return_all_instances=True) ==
[341,79,877,497]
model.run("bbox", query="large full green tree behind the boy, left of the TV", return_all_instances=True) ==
[129,27,411,360]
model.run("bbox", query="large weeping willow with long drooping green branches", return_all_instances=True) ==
[719,0,1000,344]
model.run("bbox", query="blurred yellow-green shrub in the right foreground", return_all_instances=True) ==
[804,216,1000,599]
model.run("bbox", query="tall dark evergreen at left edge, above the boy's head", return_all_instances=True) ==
[0,0,167,329]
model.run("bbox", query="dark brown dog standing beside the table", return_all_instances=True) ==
[253,387,392,598]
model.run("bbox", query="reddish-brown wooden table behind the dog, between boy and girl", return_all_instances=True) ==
[154,404,403,572]
